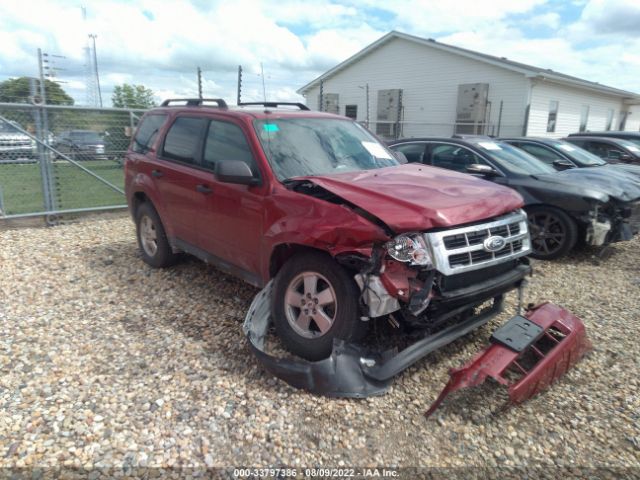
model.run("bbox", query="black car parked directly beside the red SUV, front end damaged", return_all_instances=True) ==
[389,136,640,260]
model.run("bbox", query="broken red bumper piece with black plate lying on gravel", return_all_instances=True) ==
[426,303,591,417]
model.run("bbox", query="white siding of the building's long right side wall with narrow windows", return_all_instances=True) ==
[527,80,629,138]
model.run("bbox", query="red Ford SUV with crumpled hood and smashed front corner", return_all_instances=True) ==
[125,99,530,361]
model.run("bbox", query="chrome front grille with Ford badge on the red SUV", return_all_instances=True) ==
[424,211,531,275]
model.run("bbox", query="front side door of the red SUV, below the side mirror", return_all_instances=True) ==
[198,120,264,283]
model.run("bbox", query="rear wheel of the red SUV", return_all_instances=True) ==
[136,202,176,268]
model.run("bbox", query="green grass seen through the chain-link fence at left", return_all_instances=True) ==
[0,160,126,215]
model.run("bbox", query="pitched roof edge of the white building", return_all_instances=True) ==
[297,31,640,100]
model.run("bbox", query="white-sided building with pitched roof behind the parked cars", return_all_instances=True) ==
[298,32,640,138]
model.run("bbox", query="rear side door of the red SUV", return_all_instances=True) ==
[149,116,207,245]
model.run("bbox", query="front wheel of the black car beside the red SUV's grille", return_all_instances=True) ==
[527,206,578,260]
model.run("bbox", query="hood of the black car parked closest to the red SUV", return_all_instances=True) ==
[536,166,640,202]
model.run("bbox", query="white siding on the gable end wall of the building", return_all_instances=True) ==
[305,38,528,137]
